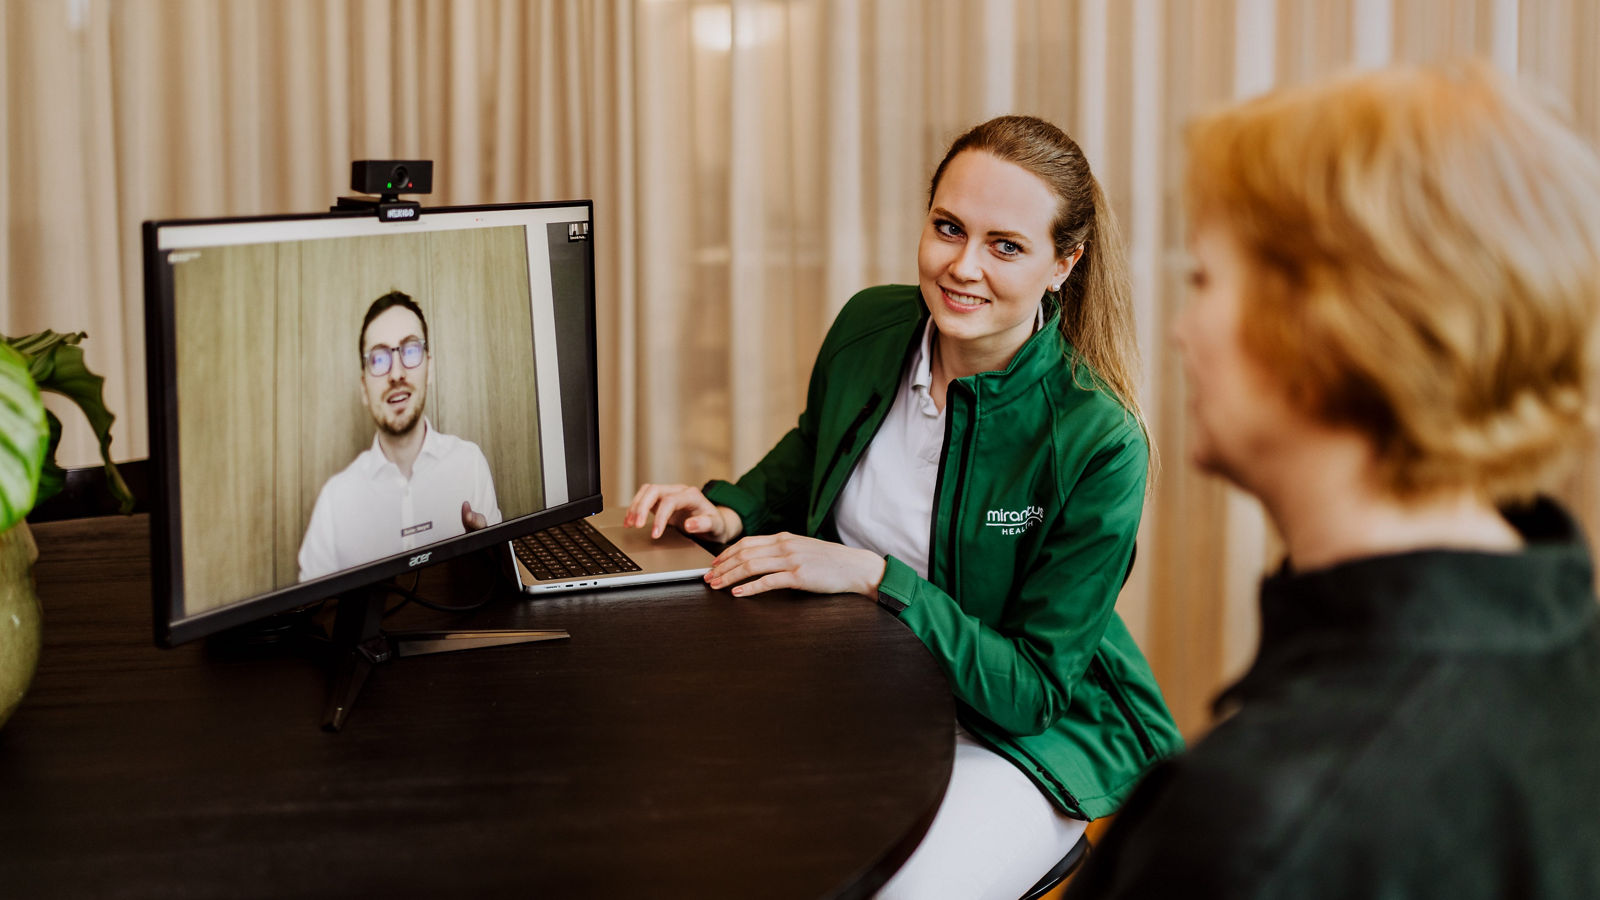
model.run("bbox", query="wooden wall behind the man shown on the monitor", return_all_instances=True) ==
[174,226,544,615]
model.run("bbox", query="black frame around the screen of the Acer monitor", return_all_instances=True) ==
[142,200,603,647]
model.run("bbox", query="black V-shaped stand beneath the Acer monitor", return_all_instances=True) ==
[322,585,571,732]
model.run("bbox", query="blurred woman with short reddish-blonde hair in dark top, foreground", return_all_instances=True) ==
[1070,59,1600,900]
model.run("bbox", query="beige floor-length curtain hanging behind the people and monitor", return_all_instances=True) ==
[12,0,1600,735]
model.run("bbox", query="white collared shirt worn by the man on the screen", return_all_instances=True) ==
[299,420,501,581]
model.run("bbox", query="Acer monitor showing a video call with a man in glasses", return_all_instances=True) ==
[144,200,600,645]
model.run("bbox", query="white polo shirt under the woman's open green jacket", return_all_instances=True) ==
[834,304,1045,578]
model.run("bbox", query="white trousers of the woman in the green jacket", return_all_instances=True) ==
[877,727,1088,900]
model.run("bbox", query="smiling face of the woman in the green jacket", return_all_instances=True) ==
[917,151,1072,359]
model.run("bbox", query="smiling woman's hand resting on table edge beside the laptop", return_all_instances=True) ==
[706,532,886,599]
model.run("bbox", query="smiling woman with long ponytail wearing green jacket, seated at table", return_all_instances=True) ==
[629,115,1179,900]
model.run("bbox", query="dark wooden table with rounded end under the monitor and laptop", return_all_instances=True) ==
[0,516,954,898]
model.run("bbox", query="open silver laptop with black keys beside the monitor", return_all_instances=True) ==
[507,509,712,594]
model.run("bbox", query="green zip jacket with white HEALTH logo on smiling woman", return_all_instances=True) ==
[706,285,1182,818]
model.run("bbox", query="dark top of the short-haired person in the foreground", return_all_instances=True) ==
[1069,501,1600,900]
